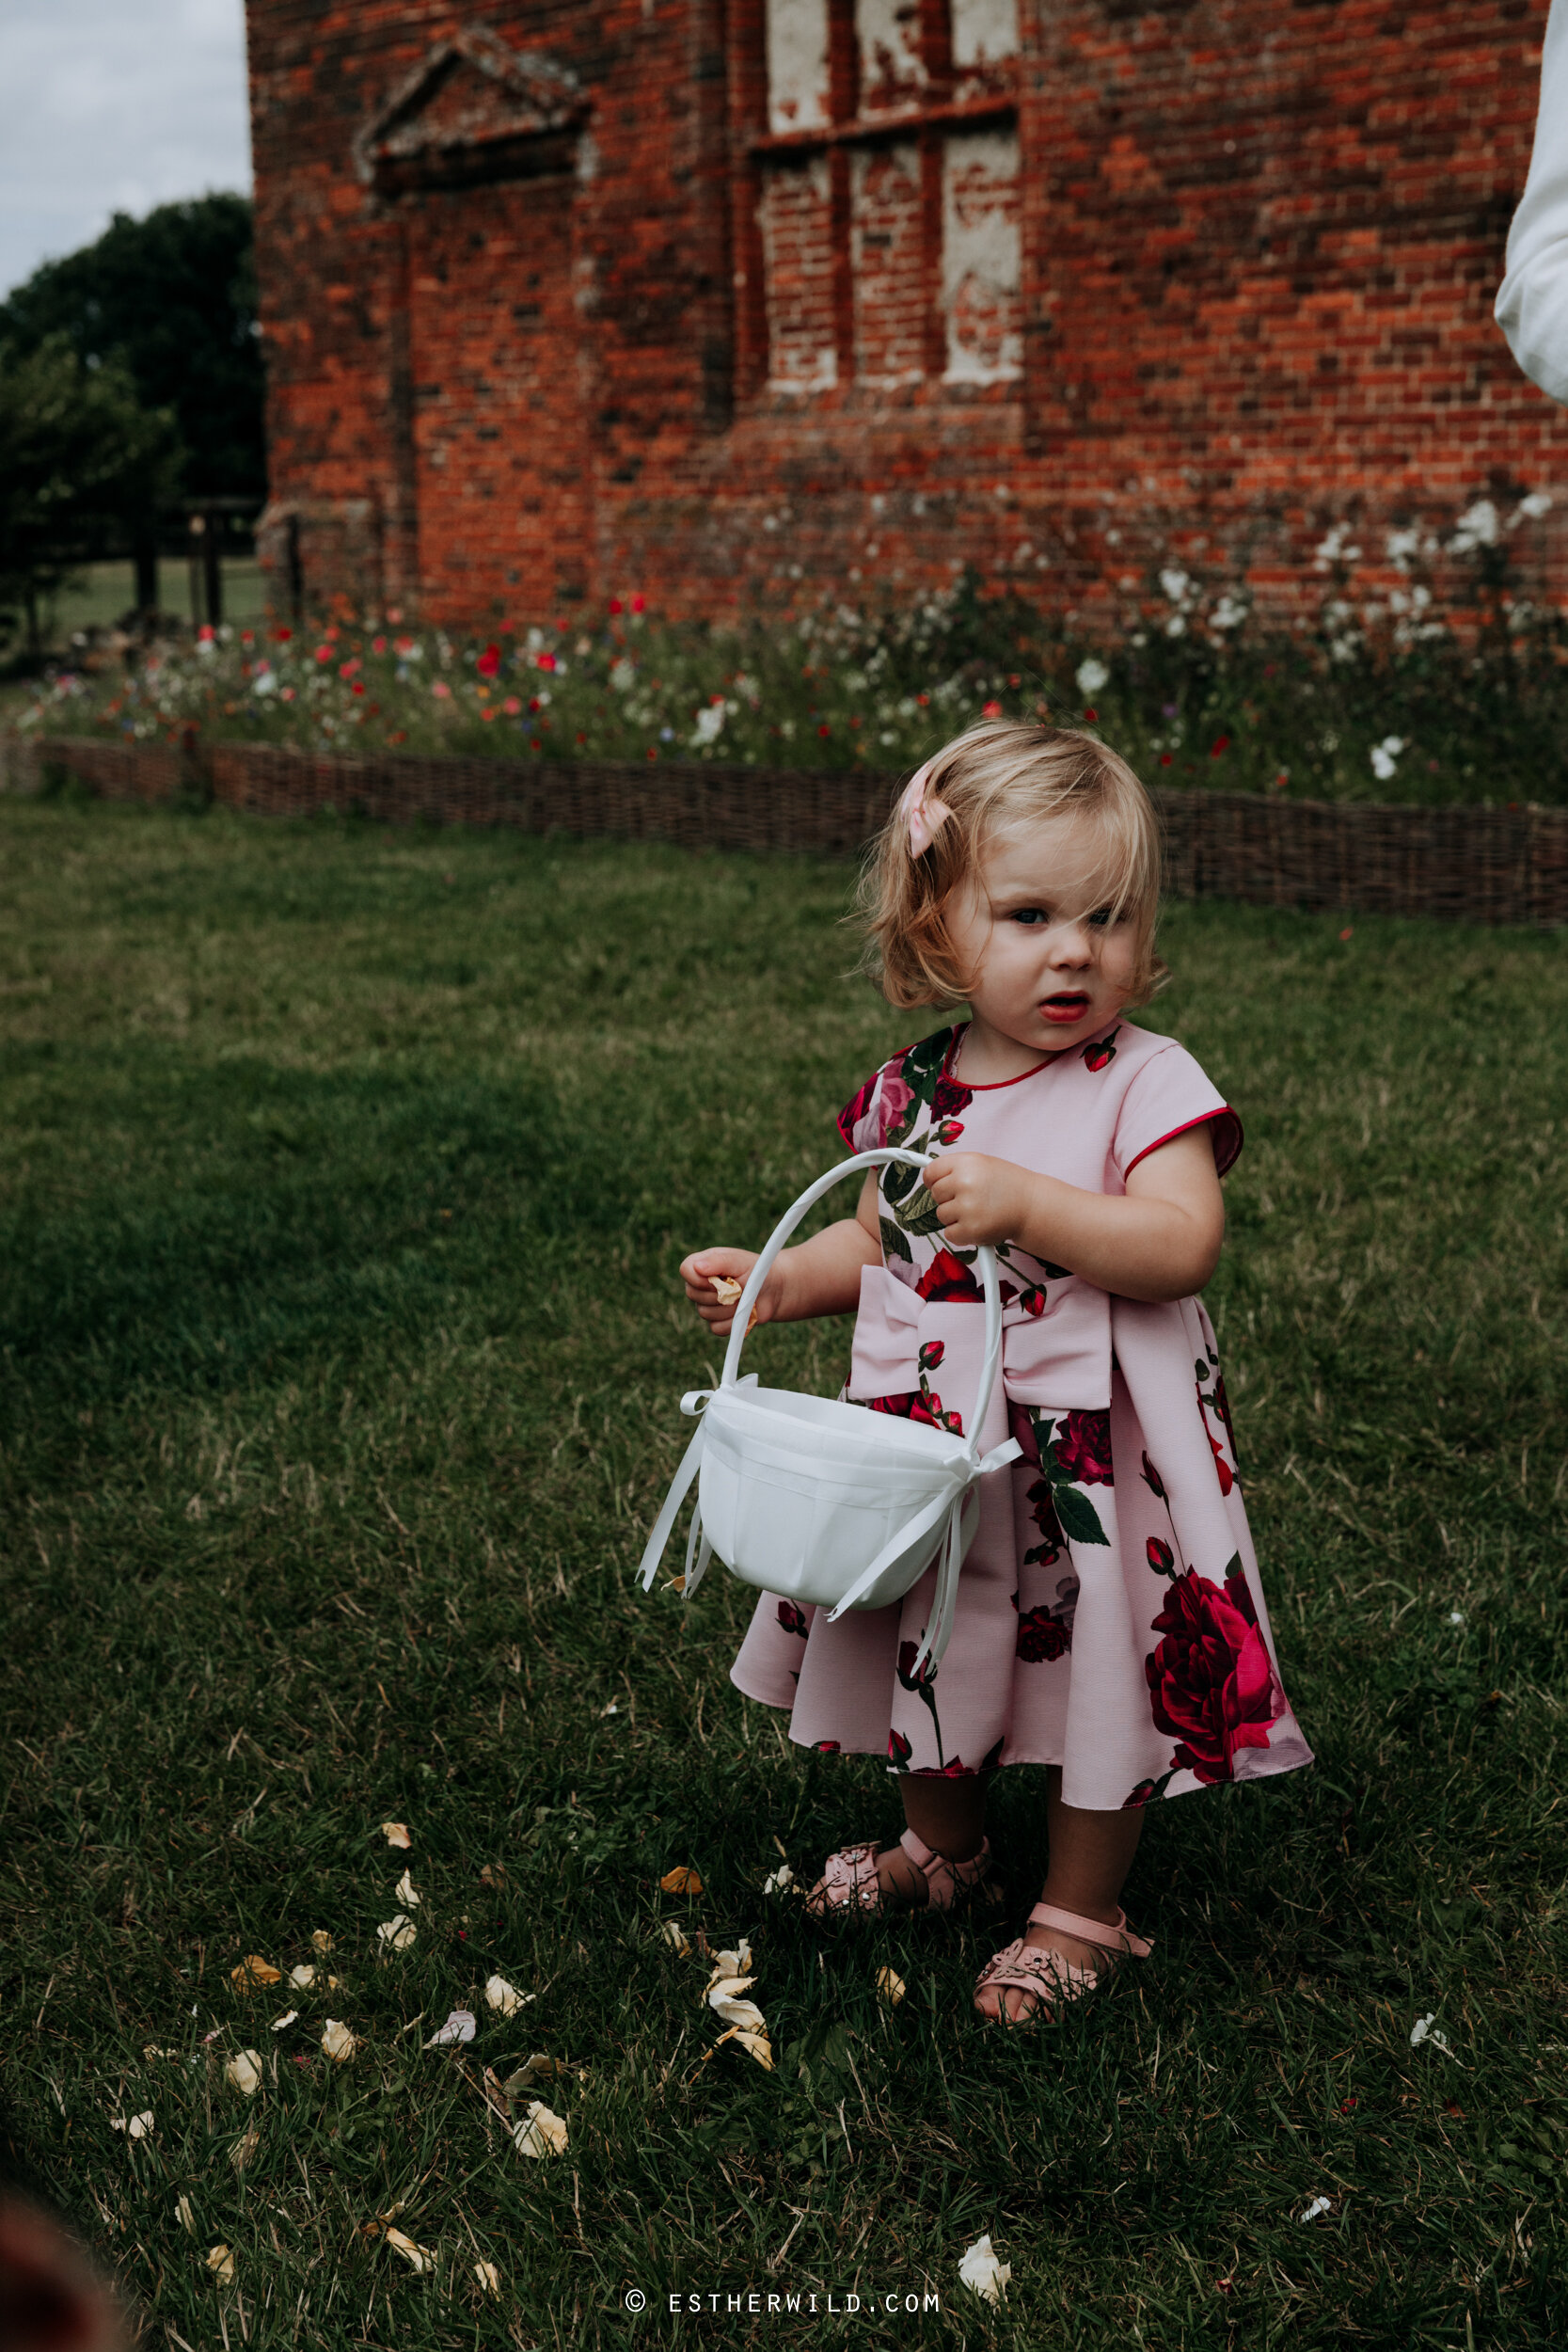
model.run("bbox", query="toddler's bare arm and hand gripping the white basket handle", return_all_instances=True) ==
[927,1127,1225,1298]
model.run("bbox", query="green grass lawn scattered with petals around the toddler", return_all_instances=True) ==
[0,803,1568,2352]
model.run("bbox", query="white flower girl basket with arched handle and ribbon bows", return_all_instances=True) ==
[641,1151,1021,1673]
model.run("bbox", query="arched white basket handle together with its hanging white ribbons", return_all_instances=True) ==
[640,1148,1022,1673]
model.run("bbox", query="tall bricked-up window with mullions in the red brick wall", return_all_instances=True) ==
[734,0,1022,395]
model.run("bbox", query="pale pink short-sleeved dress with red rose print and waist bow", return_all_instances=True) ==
[731,1021,1312,1811]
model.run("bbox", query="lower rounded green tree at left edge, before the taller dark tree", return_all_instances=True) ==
[0,334,179,652]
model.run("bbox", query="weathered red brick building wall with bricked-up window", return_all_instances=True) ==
[249,0,1568,626]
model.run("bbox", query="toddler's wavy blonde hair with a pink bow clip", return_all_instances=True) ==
[858,720,1166,1011]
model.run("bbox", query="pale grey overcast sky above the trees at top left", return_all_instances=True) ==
[0,0,251,294]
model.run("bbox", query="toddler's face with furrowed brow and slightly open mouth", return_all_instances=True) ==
[952,817,1138,1054]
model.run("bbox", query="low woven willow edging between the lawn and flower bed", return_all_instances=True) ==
[12,737,1568,930]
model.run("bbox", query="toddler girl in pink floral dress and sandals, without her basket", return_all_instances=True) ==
[682,723,1312,2018]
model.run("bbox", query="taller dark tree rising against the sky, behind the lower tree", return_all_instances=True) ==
[0,196,265,499]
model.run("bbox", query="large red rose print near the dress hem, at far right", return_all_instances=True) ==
[1145,1555,1286,1786]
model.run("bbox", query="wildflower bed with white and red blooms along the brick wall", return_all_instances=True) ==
[28,497,1568,803]
